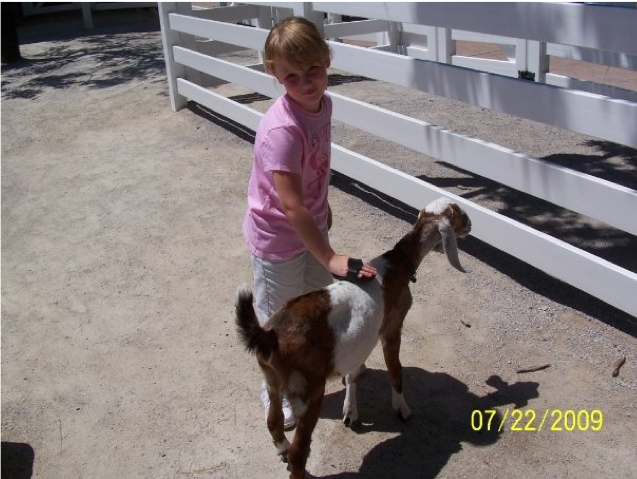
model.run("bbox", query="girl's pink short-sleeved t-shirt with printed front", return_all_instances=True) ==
[243,95,332,259]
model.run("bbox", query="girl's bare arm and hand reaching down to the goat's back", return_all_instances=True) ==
[273,171,376,278]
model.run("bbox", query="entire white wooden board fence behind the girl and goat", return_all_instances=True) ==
[159,1,637,316]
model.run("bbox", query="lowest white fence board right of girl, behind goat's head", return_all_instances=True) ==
[332,145,637,315]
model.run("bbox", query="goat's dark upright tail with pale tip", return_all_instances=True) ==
[235,285,277,361]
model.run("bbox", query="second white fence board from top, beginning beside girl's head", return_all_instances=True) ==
[330,42,637,148]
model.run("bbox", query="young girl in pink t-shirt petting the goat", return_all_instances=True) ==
[243,17,376,428]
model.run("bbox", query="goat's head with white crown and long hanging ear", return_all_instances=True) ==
[416,197,471,273]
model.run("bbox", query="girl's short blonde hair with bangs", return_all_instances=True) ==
[263,17,332,73]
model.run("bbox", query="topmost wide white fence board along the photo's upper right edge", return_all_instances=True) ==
[313,1,637,55]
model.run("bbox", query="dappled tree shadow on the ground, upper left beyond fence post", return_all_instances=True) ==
[0,12,166,99]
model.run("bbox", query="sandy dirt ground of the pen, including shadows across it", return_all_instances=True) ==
[0,12,637,479]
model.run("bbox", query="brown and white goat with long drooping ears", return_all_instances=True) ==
[236,198,471,479]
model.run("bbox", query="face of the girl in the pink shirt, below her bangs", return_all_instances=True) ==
[272,58,327,113]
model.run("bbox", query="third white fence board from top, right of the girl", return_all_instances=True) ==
[332,93,637,235]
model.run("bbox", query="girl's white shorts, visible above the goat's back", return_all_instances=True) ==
[252,251,334,324]
